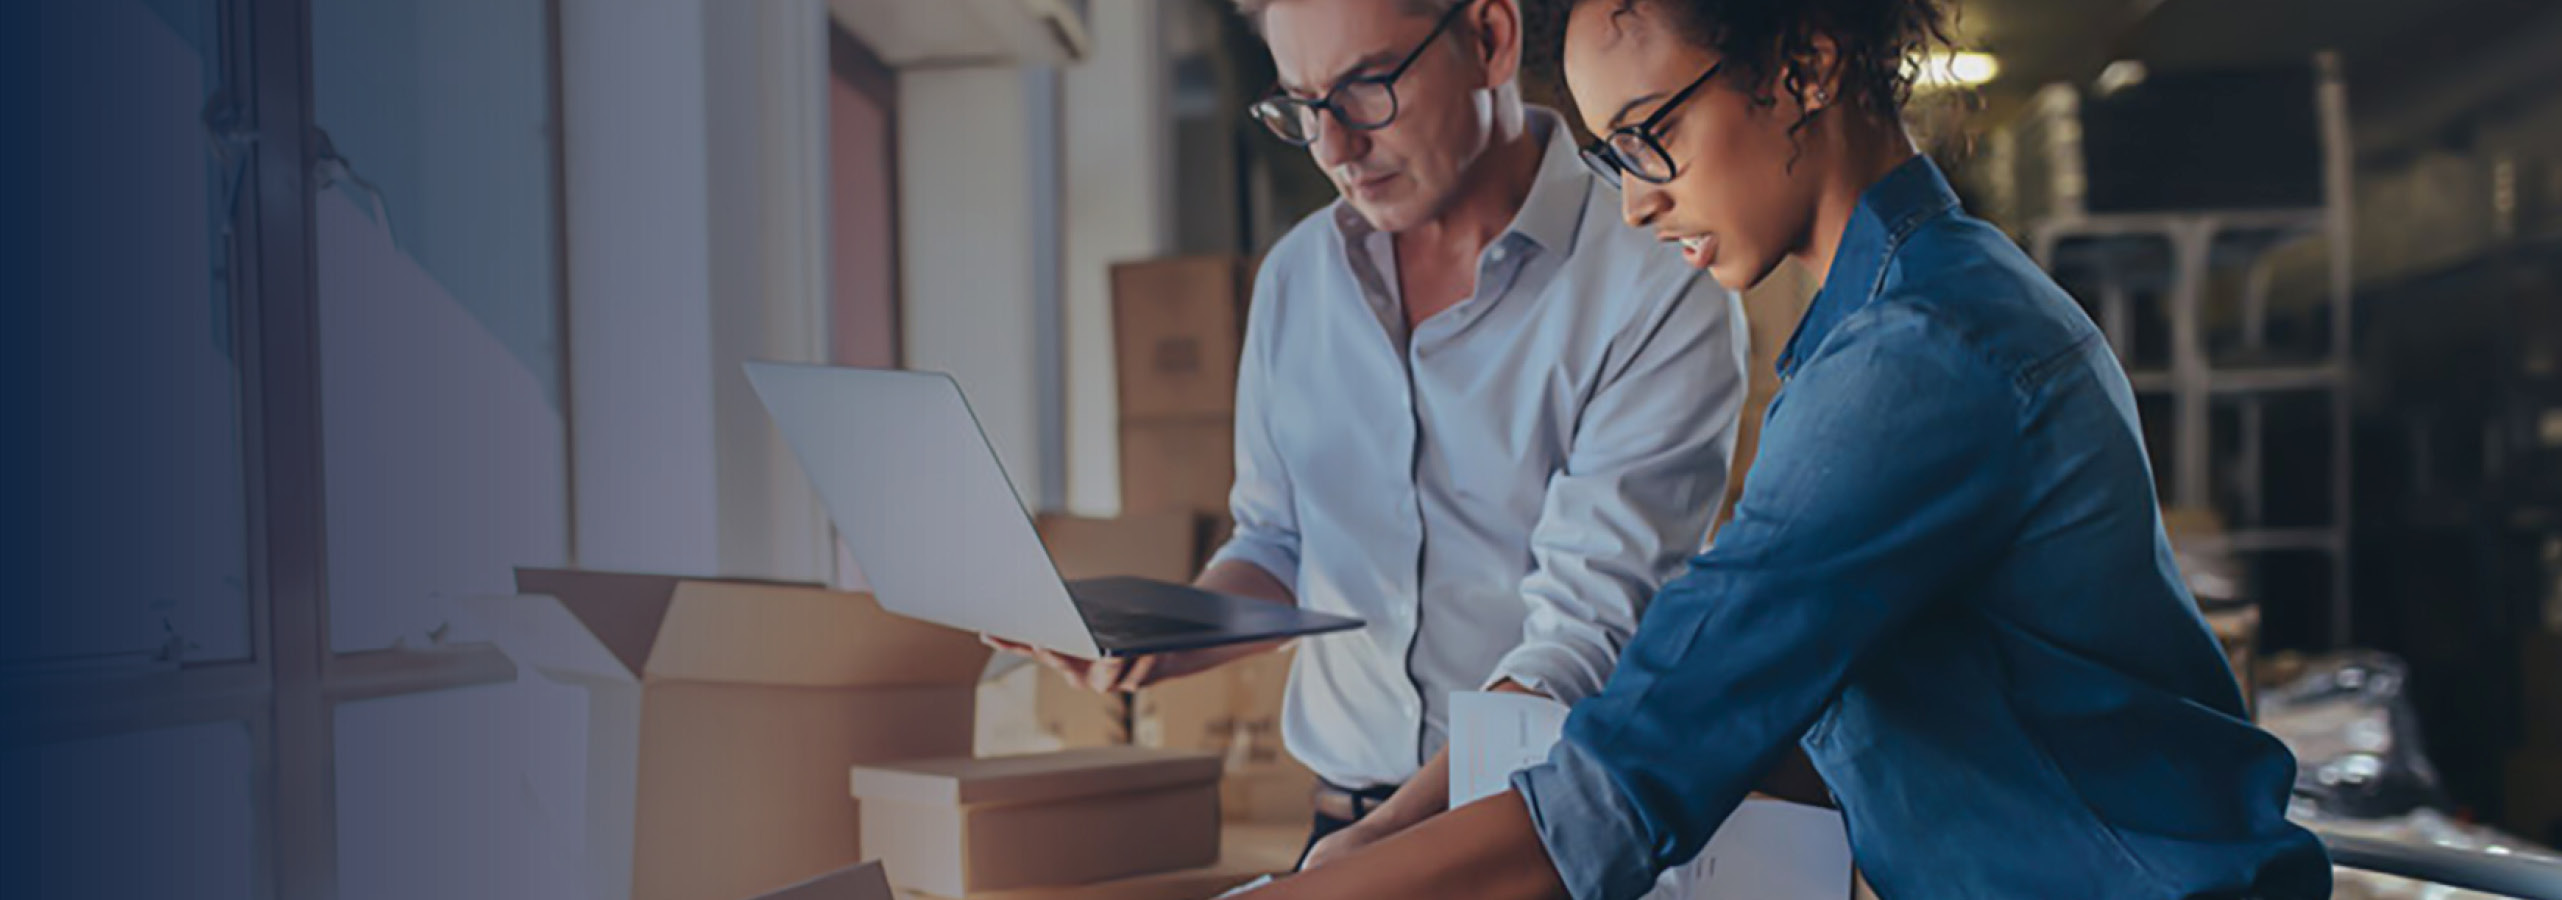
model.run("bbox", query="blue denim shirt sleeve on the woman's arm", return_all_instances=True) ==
[1512,308,2021,900]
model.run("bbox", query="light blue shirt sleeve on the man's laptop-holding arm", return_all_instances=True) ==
[1209,254,1299,595]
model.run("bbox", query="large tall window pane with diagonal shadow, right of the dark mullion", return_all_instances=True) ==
[310,0,569,651]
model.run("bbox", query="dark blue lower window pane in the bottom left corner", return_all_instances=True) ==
[36,723,259,900]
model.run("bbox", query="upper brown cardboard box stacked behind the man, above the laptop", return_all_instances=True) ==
[1112,256,1253,421]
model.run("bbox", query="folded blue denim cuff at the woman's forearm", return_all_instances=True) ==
[1512,741,1658,900]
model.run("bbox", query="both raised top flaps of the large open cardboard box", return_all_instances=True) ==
[466,569,989,687]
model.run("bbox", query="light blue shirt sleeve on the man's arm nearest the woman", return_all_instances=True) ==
[1486,274,1750,703]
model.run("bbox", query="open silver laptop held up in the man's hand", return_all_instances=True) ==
[746,362,1360,659]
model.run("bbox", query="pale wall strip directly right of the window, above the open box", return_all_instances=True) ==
[561,0,720,572]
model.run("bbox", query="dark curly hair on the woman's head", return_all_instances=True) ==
[1524,0,1955,133]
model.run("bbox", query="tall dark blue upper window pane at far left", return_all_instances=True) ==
[30,0,249,664]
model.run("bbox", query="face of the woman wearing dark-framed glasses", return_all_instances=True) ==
[1563,0,1822,290]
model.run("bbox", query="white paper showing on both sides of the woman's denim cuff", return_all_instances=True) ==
[1450,692,1850,900]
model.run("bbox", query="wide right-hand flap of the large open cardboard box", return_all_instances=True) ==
[643,579,989,687]
